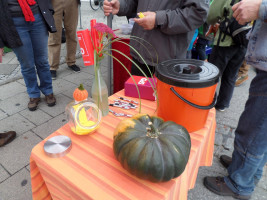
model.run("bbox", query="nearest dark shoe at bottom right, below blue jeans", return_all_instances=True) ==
[204,176,251,199]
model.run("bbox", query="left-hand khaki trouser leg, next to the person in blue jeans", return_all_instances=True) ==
[48,0,65,70]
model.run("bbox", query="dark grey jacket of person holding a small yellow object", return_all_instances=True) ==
[118,0,209,66]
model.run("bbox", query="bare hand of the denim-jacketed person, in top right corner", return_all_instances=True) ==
[232,0,262,25]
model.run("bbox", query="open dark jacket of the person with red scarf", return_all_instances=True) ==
[0,0,57,48]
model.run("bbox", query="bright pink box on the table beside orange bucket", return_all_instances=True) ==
[124,76,156,101]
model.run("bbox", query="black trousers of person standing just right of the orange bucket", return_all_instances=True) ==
[209,45,246,109]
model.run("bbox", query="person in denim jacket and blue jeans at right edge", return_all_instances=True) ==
[204,0,267,199]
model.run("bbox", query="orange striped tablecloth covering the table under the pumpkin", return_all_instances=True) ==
[30,91,216,200]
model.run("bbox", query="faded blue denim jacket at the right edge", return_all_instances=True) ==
[246,0,267,71]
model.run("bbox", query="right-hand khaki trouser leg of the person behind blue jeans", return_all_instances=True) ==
[64,0,78,66]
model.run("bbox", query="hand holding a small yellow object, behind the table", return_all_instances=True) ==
[134,11,156,30]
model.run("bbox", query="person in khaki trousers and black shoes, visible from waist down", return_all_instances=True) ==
[48,0,81,79]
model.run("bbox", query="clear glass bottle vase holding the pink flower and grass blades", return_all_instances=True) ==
[91,55,109,116]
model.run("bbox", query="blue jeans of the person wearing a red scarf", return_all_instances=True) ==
[13,14,53,98]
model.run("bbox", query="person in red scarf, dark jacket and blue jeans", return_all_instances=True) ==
[0,0,56,111]
